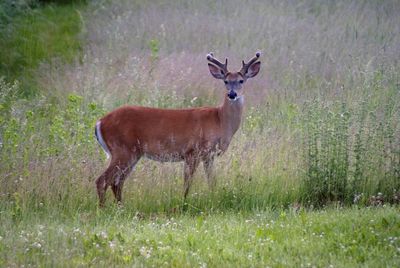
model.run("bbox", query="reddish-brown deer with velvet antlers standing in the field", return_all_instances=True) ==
[95,52,261,207]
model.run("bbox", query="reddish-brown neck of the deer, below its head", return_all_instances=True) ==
[219,96,244,140]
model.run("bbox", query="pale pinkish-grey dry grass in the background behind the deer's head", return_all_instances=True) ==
[47,1,400,104]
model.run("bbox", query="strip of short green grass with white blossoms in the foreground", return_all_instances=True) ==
[0,207,400,267]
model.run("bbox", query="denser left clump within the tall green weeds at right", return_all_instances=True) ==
[303,100,350,205]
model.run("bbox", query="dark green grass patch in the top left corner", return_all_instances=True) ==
[0,2,84,96]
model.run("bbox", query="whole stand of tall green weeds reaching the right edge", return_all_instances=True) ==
[302,76,400,205]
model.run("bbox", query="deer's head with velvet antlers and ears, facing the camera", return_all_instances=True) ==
[207,52,261,101]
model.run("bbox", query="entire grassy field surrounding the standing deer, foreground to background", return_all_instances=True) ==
[0,0,400,267]
